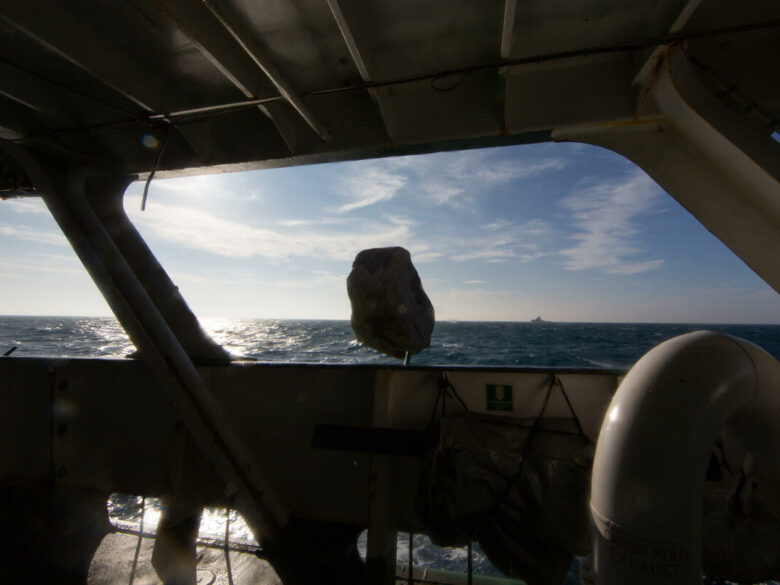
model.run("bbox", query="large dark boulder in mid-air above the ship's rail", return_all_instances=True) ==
[347,247,434,358]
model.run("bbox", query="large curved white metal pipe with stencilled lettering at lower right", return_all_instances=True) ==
[591,331,780,585]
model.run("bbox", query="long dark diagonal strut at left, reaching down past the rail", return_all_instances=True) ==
[0,142,289,539]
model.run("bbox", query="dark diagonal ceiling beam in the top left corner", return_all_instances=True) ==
[0,0,175,112]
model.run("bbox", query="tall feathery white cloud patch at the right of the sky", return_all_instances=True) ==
[559,171,664,274]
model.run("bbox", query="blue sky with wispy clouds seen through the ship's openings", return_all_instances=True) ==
[0,143,780,323]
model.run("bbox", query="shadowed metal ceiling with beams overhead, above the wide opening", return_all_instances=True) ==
[0,0,780,181]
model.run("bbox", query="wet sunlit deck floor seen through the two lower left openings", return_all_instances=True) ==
[88,532,281,585]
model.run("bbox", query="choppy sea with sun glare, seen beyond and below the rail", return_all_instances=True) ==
[0,316,780,585]
